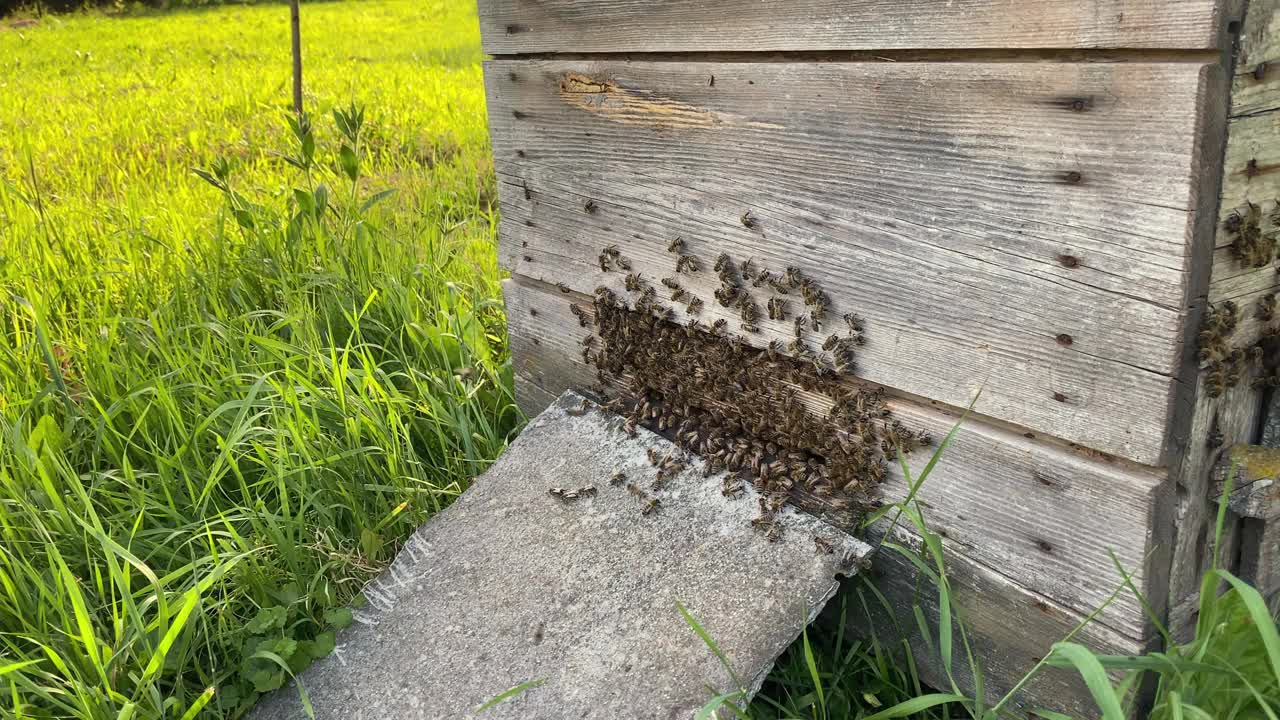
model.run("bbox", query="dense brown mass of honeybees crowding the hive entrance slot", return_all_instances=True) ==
[573,240,931,539]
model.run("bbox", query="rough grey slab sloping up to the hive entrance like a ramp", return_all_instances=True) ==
[250,393,870,720]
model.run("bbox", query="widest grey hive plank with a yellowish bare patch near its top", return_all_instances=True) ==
[485,60,1216,465]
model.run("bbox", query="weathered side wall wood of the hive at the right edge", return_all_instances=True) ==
[1167,0,1280,641]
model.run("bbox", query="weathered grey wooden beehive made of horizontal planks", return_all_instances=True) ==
[480,0,1280,714]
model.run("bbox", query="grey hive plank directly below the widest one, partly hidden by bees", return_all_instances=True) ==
[504,277,1171,638]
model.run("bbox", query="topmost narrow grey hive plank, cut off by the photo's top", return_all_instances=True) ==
[480,0,1225,55]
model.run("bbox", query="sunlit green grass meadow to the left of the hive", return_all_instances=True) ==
[0,0,520,719]
